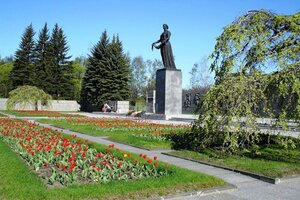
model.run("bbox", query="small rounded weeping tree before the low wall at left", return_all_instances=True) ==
[6,85,52,110]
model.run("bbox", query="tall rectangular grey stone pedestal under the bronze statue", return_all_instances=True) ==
[155,69,182,118]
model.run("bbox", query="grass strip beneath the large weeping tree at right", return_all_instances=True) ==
[171,147,300,178]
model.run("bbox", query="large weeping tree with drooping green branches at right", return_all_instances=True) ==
[193,10,300,151]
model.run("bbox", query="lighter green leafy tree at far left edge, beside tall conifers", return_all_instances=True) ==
[0,61,14,98]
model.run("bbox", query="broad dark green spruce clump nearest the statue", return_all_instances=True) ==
[81,31,130,111]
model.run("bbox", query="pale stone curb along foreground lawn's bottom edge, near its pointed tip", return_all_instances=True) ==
[150,184,237,200]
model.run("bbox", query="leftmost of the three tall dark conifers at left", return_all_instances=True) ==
[10,24,35,89]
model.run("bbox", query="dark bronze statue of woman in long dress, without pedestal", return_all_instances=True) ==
[152,24,176,69]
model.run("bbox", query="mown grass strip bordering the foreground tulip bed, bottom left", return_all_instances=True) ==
[0,140,227,199]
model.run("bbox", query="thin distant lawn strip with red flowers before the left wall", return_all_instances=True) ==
[1,110,81,117]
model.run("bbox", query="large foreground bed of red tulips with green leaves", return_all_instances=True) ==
[0,118,172,185]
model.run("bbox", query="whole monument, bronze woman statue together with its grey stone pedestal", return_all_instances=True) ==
[152,24,182,118]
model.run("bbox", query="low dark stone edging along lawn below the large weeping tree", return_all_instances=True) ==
[162,152,300,184]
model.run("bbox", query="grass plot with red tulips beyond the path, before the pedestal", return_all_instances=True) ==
[38,117,190,149]
